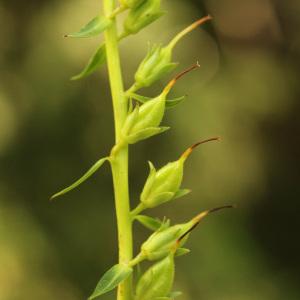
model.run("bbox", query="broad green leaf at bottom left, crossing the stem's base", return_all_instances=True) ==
[89,264,133,300]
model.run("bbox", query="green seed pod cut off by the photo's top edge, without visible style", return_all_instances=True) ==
[124,0,163,35]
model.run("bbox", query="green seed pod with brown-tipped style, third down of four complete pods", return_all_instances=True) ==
[140,138,218,208]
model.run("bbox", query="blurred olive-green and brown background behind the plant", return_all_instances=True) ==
[0,0,300,300]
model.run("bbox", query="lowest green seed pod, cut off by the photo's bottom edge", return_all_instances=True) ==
[135,253,175,300]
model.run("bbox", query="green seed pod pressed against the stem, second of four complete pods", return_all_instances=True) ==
[122,64,199,144]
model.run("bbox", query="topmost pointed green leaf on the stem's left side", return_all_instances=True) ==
[66,16,112,38]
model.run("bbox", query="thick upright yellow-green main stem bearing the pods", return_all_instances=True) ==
[103,0,132,300]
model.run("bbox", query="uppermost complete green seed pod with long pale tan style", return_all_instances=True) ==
[134,16,211,90]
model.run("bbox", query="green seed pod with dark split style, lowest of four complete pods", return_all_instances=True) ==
[141,206,232,261]
